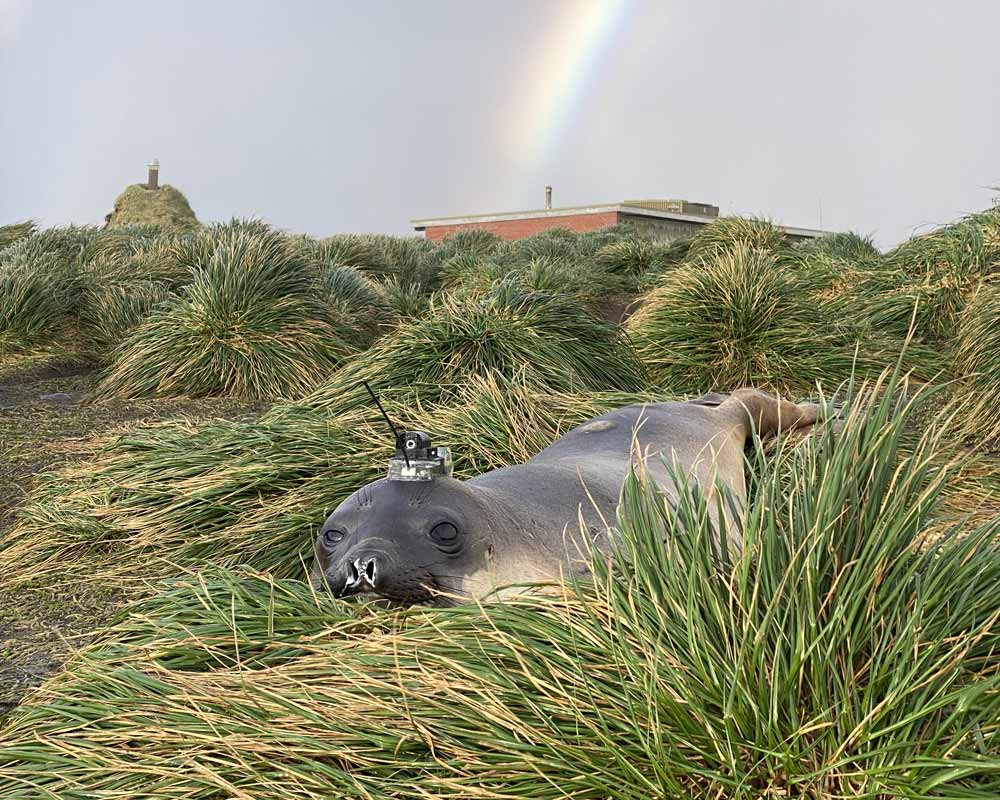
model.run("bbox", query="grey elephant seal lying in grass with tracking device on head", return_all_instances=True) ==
[312,389,818,604]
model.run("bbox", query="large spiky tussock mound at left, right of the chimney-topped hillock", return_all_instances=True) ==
[91,227,349,399]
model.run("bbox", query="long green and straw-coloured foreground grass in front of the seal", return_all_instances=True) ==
[0,376,1000,800]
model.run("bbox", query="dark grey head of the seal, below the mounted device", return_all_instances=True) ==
[313,477,492,604]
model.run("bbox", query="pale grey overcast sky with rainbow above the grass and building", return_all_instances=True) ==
[0,0,1000,247]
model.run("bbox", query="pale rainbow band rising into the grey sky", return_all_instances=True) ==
[507,0,629,174]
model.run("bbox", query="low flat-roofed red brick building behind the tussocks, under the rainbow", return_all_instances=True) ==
[411,191,823,242]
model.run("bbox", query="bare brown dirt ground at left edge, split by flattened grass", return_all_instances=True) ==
[0,354,262,718]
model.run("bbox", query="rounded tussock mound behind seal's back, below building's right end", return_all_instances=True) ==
[628,242,880,394]
